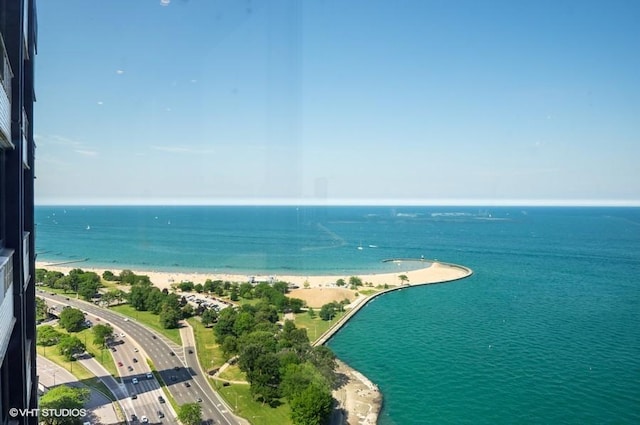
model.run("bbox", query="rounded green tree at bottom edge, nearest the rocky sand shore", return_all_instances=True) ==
[289,382,333,425]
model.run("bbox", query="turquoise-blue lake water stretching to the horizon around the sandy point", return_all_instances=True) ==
[36,207,640,425]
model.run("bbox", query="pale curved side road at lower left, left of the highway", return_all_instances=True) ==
[37,356,120,425]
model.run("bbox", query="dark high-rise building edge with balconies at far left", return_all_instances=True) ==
[0,0,38,425]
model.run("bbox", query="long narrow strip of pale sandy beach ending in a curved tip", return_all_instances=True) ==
[36,262,467,289]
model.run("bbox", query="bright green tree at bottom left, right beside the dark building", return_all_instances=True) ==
[39,385,89,425]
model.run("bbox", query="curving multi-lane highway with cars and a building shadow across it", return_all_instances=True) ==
[38,291,246,425]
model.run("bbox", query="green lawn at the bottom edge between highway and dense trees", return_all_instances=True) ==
[216,382,292,425]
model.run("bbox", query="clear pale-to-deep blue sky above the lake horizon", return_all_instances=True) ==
[34,0,640,205]
